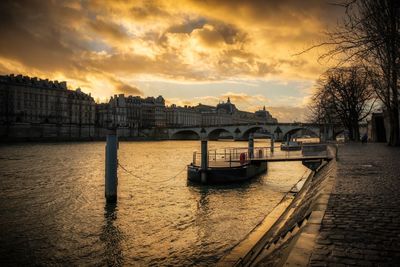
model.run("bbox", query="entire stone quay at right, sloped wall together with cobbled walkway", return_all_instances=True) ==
[220,143,400,266]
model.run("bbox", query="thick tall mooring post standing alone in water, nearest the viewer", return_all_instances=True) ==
[105,128,118,202]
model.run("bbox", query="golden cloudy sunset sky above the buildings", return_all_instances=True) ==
[0,0,343,122]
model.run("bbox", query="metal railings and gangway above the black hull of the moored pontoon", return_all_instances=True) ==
[192,143,333,167]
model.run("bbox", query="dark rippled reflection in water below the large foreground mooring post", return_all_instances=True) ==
[100,203,123,266]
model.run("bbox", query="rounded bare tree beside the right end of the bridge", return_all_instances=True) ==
[311,66,376,141]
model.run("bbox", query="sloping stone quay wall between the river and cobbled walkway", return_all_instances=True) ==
[217,159,336,266]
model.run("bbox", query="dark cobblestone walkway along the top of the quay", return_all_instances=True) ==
[310,143,400,266]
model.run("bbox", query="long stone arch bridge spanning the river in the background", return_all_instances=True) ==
[167,123,336,140]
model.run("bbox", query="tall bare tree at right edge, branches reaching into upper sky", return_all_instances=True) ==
[307,0,400,146]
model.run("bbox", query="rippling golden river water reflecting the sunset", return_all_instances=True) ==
[0,140,307,266]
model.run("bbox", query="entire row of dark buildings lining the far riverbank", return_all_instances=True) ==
[0,74,277,139]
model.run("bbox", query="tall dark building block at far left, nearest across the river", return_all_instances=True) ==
[0,74,95,138]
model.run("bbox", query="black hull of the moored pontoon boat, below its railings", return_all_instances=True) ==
[187,162,268,184]
